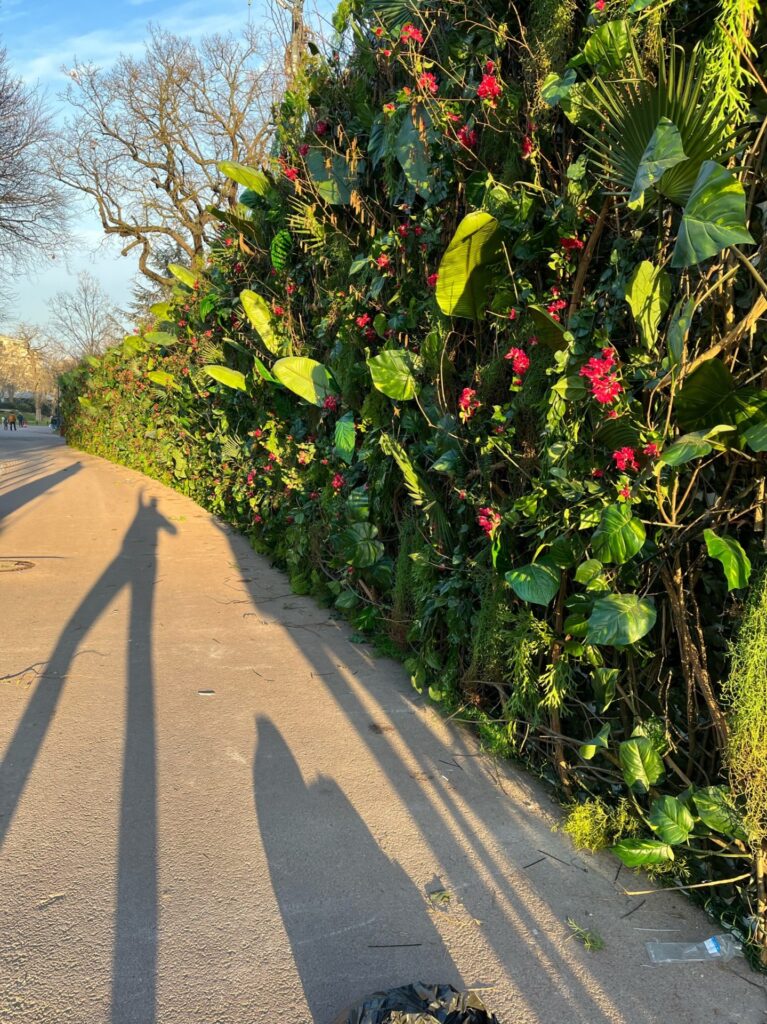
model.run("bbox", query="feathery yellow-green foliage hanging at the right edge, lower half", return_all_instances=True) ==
[724,572,767,847]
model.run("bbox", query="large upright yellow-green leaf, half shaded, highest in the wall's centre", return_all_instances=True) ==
[436,210,500,319]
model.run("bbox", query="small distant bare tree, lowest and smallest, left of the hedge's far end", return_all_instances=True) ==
[49,270,125,358]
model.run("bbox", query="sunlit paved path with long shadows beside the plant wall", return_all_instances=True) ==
[0,429,767,1024]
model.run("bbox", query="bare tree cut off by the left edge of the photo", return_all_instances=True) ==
[0,49,67,303]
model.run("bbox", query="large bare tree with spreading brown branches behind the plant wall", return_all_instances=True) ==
[52,28,281,284]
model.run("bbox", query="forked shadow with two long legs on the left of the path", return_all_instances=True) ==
[0,495,176,1024]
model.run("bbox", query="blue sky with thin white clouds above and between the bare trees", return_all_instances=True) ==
[0,0,262,331]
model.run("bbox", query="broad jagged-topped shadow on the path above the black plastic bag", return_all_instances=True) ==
[253,717,462,1022]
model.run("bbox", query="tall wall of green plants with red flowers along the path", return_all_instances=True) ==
[65,0,767,948]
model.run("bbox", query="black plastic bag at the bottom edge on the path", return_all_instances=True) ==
[336,982,499,1024]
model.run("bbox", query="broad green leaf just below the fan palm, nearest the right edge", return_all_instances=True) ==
[671,160,754,267]
